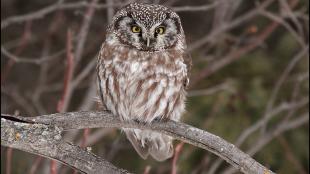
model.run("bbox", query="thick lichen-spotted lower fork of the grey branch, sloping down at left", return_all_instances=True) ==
[1,117,129,174]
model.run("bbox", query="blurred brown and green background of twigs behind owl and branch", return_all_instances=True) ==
[1,0,309,174]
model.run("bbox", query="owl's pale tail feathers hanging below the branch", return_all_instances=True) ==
[124,129,173,161]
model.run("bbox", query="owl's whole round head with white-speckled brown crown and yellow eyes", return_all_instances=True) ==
[107,3,185,51]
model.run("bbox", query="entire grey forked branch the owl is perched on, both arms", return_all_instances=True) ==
[1,111,273,174]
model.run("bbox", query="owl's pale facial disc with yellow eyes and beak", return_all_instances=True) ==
[114,8,181,51]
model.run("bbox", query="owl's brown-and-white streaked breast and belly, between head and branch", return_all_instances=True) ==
[99,44,187,122]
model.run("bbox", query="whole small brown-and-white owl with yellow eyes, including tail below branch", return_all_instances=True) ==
[97,3,191,161]
